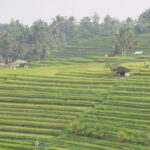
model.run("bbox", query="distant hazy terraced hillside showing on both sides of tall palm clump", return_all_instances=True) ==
[52,34,150,58]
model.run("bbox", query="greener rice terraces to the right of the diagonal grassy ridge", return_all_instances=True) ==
[49,63,150,150]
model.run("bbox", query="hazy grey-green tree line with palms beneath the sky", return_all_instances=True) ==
[0,9,150,60]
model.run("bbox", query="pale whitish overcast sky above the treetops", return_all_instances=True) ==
[0,0,150,25]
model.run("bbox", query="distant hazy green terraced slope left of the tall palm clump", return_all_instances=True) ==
[53,36,112,58]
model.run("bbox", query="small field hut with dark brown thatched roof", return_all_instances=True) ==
[113,67,130,77]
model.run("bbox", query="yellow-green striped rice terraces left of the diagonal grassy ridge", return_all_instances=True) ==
[0,60,114,150]
